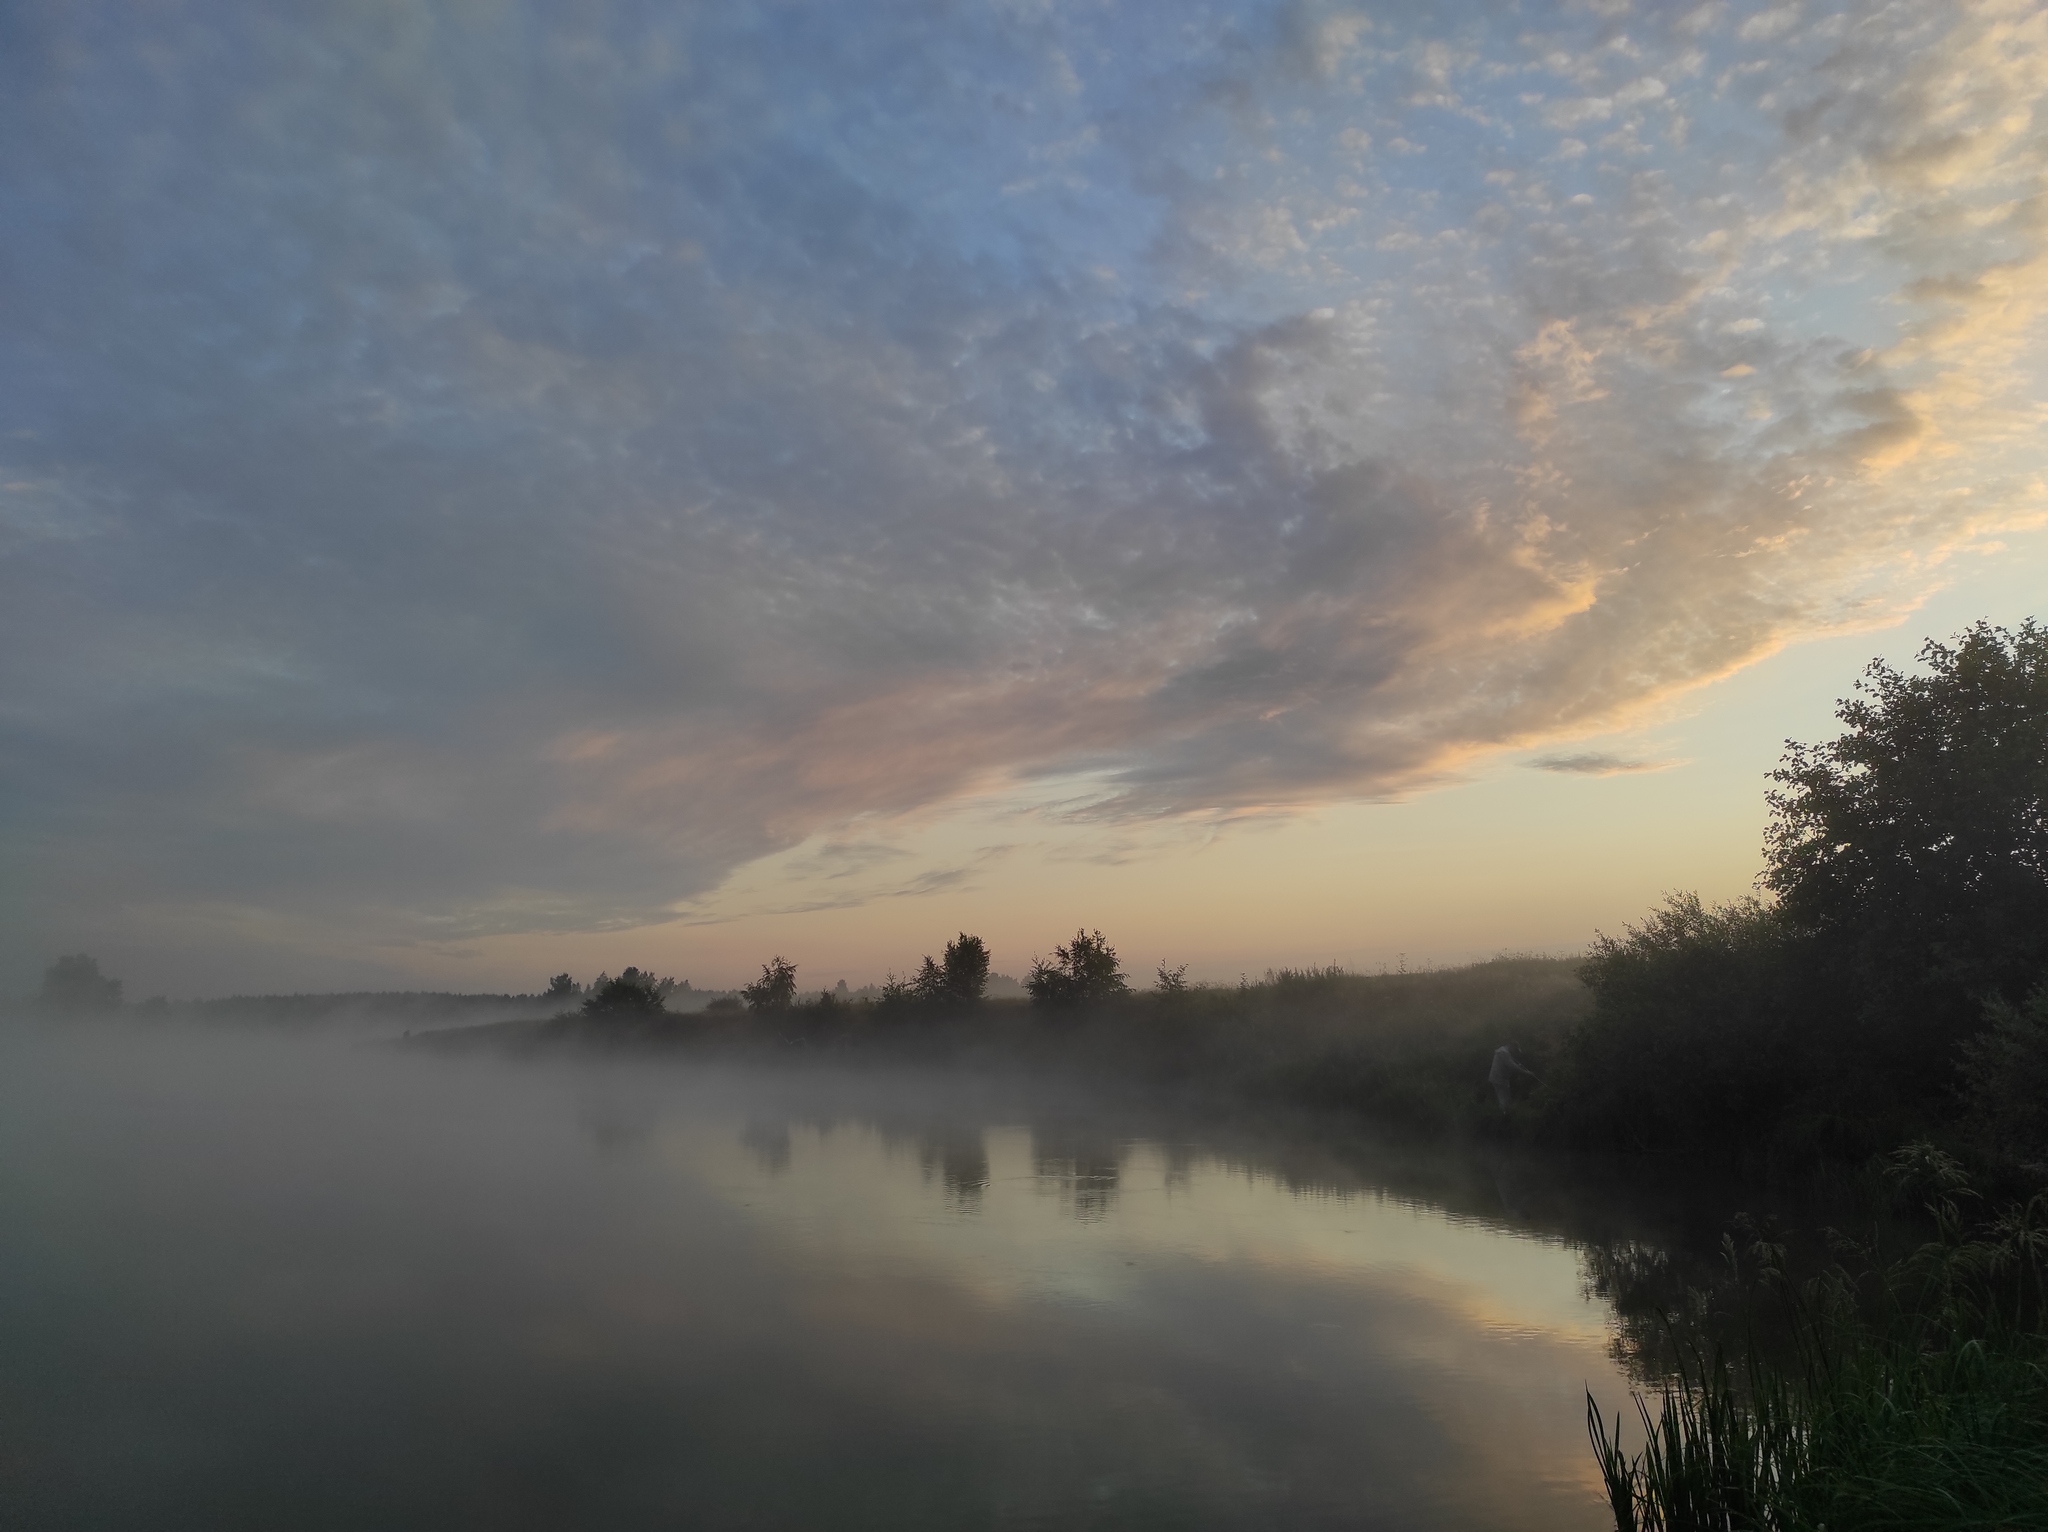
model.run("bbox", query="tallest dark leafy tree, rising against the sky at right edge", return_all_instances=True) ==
[1761,621,2048,1086]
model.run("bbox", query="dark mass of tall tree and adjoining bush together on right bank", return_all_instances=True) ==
[1542,623,2048,1163]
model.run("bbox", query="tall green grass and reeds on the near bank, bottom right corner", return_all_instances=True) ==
[1587,1145,2048,1532]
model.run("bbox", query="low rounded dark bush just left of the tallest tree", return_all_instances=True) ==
[1546,893,1806,1151]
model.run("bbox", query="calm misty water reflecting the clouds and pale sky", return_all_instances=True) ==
[0,1026,1626,1532]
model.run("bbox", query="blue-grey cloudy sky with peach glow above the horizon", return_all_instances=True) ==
[0,0,2048,995]
